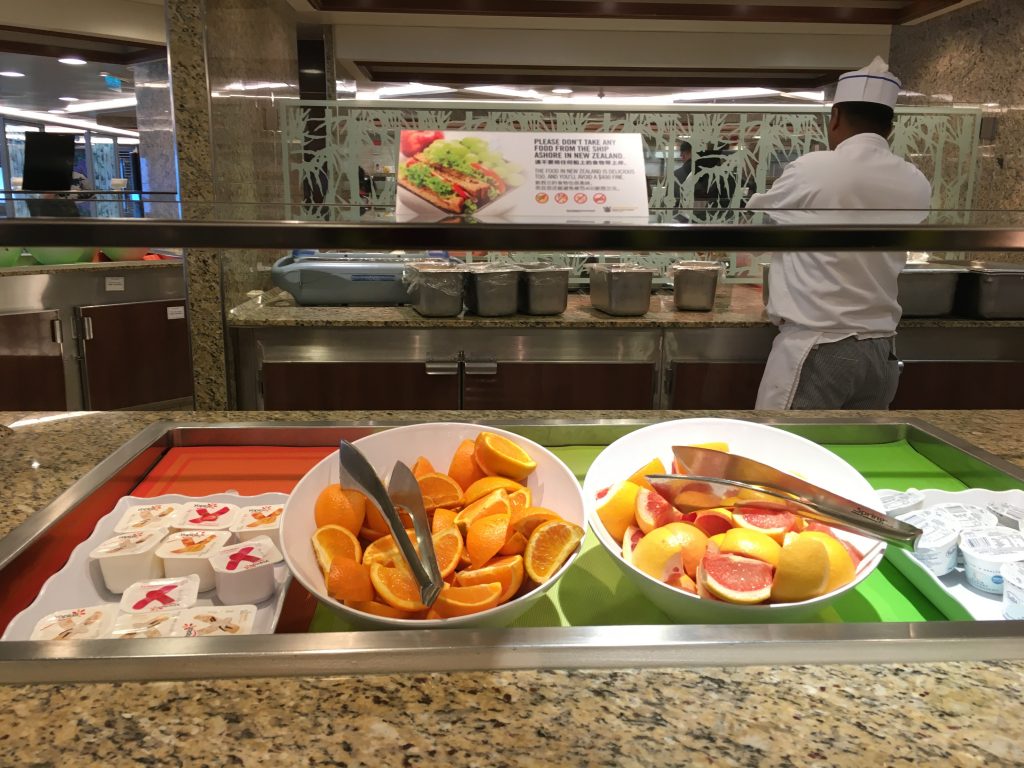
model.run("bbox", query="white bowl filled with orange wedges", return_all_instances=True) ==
[281,422,586,629]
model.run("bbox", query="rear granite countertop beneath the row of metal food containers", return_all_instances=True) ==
[227,285,1024,328]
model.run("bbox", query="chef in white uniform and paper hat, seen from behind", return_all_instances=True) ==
[746,57,932,410]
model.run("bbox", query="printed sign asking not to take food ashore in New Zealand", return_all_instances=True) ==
[397,131,648,221]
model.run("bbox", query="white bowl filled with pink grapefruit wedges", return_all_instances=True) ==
[583,419,885,624]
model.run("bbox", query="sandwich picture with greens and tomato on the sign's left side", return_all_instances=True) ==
[397,131,526,216]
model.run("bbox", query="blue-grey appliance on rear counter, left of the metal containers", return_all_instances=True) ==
[270,252,430,306]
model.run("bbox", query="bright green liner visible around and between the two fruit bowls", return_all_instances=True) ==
[310,440,972,632]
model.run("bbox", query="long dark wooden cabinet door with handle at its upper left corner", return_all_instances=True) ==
[463,362,657,411]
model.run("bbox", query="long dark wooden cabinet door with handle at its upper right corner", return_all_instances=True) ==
[262,362,459,411]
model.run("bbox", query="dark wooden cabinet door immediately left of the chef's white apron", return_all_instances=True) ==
[669,361,765,410]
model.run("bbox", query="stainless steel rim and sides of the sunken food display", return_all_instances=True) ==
[0,419,1024,683]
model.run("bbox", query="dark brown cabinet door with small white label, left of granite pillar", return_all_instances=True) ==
[79,299,193,411]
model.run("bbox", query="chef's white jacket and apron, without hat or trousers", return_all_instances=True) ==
[746,133,932,409]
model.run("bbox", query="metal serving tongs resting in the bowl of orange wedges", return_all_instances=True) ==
[338,440,444,606]
